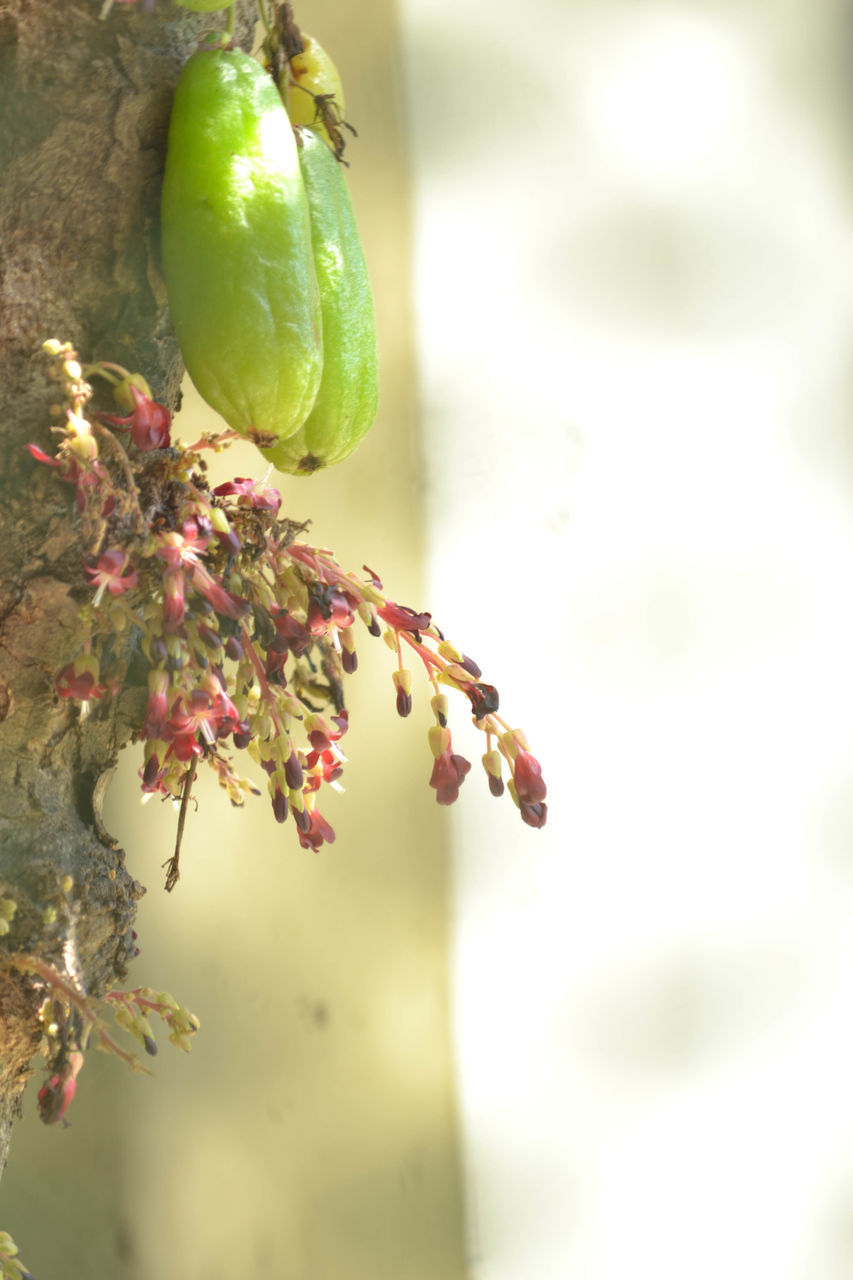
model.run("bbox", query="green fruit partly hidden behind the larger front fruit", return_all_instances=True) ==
[264,129,379,475]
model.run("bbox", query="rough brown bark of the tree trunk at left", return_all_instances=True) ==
[0,0,256,1171]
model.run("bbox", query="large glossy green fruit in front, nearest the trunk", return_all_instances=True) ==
[163,49,323,445]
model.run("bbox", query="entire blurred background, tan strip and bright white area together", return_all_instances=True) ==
[8,0,853,1280]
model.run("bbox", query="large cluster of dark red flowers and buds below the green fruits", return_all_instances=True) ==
[29,343,547,887]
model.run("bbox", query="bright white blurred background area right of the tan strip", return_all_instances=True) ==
[402,0,853,1280]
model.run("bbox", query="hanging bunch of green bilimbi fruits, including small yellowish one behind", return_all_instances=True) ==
[163,37,378,475]
